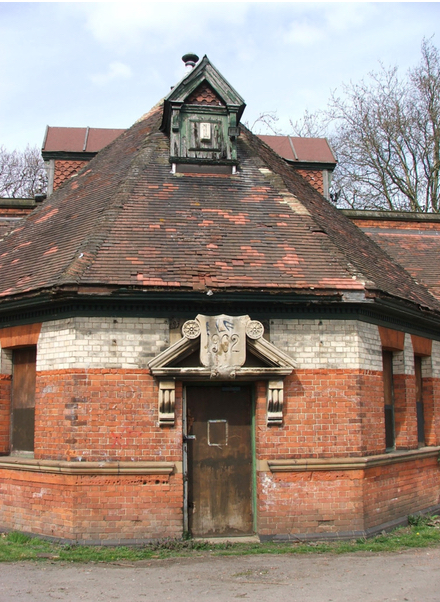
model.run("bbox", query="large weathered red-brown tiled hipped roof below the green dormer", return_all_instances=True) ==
[0,104,440,310]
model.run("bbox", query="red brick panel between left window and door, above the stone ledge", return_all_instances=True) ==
[35,369,182,462]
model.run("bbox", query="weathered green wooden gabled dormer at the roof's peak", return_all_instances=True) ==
[162,54,246,174]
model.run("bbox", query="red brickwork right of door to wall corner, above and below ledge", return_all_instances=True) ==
[256,370,378,536]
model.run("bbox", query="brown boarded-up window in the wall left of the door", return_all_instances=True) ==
[12,346,37,452]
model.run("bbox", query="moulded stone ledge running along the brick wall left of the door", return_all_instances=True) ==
[0,456,177,475]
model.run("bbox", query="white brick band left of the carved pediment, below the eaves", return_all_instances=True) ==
[37,317,169,371]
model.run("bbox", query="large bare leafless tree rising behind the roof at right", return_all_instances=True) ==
[291,40,440,212]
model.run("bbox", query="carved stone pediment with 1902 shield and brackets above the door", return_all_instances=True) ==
[149,314,296,426]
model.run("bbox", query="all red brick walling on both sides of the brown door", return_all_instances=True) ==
[0,360,440,542]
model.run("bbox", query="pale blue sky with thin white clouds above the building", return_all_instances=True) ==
[0,0,440,151]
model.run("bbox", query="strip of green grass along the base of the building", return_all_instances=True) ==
[0,515,440,563]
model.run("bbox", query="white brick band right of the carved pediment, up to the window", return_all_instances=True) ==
[270,319,382,371]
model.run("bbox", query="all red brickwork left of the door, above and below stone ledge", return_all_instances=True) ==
[0,370,183,542]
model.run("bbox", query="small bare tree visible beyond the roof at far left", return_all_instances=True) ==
[0,146,47,198]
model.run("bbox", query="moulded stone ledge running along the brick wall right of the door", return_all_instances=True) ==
[264,446,440,472]
